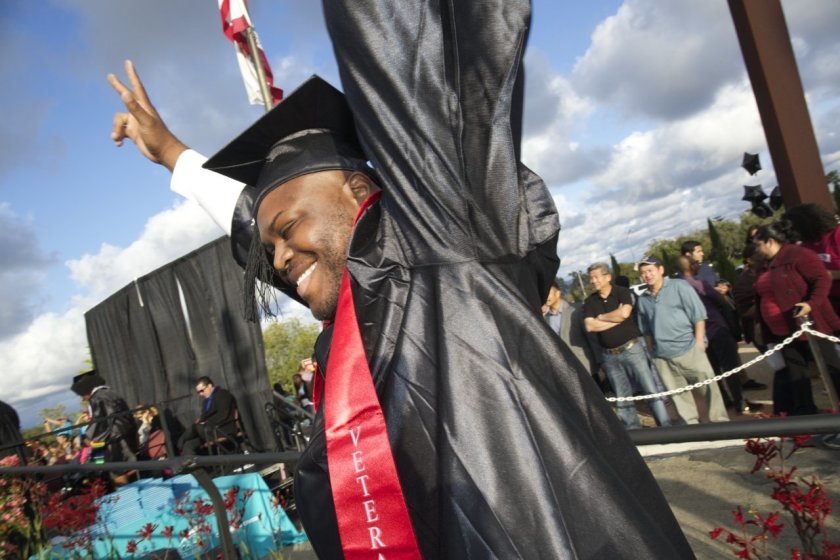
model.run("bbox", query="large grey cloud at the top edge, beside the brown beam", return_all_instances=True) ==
[572,0,744,119]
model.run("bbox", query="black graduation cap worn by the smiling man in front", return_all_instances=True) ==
[204,75,370,198]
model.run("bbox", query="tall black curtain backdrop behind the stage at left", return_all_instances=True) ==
[85,236,274,450]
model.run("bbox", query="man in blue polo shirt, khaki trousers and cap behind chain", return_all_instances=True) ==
[637,256,729,424]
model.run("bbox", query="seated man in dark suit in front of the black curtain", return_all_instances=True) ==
[180,375,236,455]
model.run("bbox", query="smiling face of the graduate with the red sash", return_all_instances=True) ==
[257,171,375,320]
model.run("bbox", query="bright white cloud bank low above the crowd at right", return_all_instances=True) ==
[555,81,772,275]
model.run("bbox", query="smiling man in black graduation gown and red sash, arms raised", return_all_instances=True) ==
[109,0,693,559]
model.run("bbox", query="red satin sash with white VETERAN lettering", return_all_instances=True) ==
[323,193,421,560]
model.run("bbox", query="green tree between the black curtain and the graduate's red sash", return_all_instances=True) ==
[263,319,321,387]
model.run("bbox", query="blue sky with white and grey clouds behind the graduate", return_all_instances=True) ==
[0,0,840,426]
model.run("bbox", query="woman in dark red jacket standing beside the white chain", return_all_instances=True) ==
[755,220,840,415]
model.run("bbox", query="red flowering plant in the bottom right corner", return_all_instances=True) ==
[709,436,840,560]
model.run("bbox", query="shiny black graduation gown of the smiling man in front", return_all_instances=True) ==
[288,0,693,560]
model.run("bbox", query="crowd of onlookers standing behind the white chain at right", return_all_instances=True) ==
[542,204,840,438]
